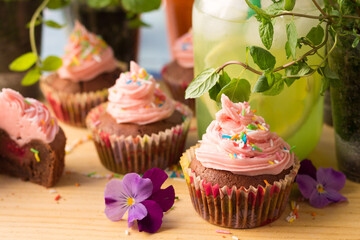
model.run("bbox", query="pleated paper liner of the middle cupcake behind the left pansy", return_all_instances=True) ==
[86,102,192,174]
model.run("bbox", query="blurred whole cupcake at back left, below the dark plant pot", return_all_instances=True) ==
[40,21,122,127]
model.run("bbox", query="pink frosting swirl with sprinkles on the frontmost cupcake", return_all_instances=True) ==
[195,94,295,176]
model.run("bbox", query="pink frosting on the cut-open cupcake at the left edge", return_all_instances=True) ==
[0,88,59,146]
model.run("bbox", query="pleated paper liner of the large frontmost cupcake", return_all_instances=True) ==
[180,145,300,228]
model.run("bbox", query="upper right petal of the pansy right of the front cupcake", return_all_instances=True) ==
[316,167,346,191]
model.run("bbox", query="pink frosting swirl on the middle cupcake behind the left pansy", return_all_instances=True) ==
[107,62,174,125]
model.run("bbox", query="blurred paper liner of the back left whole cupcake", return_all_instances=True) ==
[40,78,108,127]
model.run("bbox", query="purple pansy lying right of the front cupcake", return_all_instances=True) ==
[296,159,347,208]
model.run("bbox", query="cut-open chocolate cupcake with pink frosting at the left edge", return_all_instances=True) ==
[0,89,66,187]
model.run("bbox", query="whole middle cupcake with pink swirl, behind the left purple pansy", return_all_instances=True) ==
[86,62,192,174]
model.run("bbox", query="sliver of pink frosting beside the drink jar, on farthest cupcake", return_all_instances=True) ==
[173,30,194,68]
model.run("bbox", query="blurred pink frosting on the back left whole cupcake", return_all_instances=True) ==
[57,21,116,82]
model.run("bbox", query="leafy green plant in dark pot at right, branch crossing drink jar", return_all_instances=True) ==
[186,0,360,181]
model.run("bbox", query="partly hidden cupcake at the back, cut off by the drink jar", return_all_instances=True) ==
[162,31,195,110]
